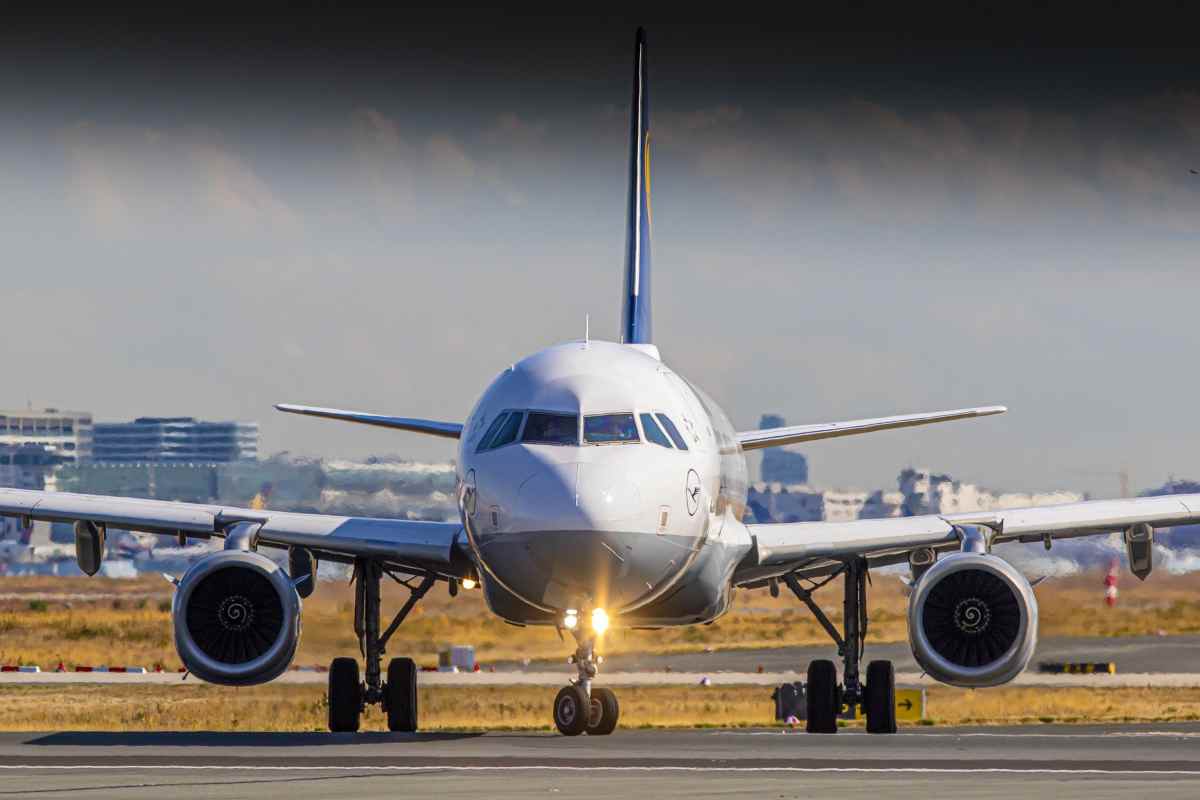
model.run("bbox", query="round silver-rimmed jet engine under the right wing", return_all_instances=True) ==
[908,553,1038,686]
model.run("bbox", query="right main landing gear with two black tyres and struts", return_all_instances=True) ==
[784,558,896,733]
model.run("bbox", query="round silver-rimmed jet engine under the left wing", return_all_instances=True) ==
[172,551,300,686]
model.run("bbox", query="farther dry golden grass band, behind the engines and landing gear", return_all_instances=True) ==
[0,573,1200,668]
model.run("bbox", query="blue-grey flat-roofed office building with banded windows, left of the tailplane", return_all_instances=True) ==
[91,416,258,464]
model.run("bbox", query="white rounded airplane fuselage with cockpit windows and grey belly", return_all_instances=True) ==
[458,341,751,626]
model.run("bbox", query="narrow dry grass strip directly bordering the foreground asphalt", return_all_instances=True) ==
[0,684,1200,730]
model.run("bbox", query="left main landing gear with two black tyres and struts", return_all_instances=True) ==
[329,559,434,733]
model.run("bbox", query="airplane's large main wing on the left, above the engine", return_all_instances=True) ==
[0,488,469,577]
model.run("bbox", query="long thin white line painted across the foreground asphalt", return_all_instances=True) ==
[0,764,1200,777]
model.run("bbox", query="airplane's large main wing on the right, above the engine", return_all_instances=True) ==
[734,494,1200,585]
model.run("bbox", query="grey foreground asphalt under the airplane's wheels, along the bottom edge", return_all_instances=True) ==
[0,723,1200,800]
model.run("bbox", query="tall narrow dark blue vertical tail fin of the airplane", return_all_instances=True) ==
[620,28,654,344]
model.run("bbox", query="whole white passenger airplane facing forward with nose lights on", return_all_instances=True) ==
[0,29,1200,735]
